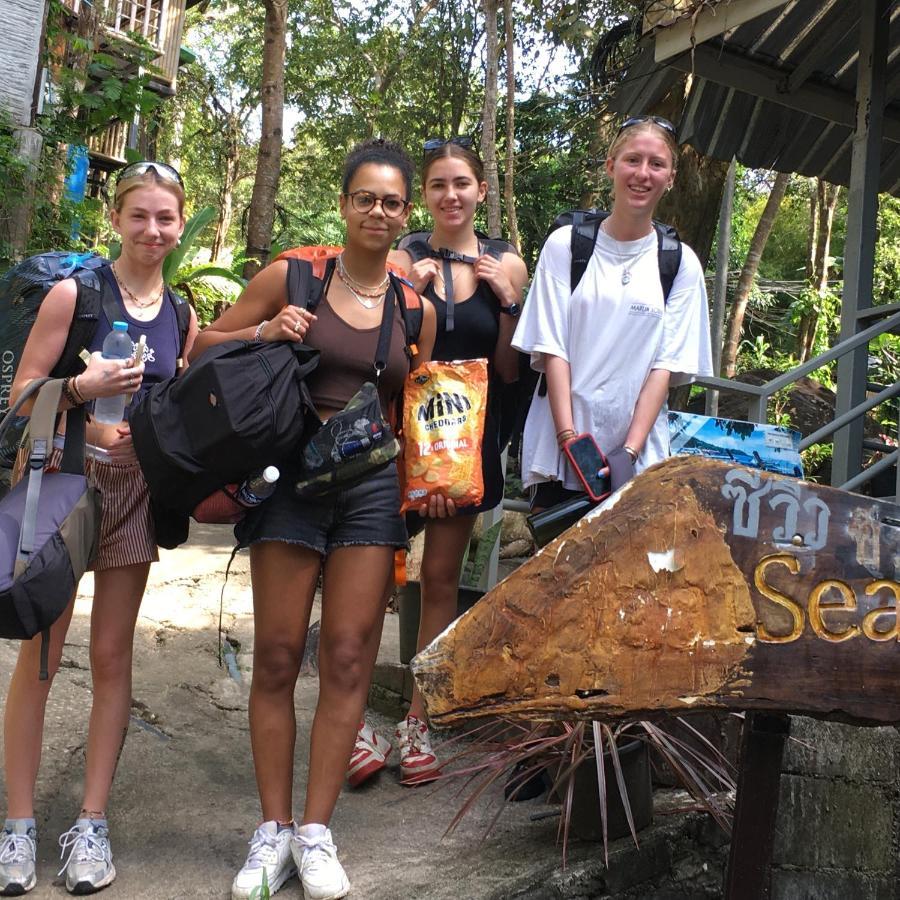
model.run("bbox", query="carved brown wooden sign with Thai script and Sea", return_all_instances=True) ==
[412,457,900,724]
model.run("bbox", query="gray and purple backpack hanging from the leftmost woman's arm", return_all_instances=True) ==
[0,378,100,680]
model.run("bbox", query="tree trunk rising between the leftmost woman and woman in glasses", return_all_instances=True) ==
[243,0,288,278]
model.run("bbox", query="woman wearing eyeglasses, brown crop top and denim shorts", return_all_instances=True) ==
[195,139,435,900]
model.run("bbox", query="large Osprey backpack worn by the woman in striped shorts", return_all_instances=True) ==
[0,251,191,468]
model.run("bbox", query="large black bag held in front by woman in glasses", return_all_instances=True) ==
[129,262,321,549]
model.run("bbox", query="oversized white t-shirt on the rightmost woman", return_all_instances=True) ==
[512,227,712,490]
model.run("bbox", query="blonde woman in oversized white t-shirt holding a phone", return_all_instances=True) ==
[512,116,712,510]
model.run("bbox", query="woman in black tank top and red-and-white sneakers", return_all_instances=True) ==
[348,138,528,785]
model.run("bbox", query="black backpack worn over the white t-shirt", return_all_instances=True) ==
[511,208,681,453]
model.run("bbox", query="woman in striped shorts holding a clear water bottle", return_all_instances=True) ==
[0,162,197,896]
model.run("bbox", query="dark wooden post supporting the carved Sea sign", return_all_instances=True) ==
[725,713,791,900]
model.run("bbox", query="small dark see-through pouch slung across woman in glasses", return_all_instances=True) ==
[295,270,400,497]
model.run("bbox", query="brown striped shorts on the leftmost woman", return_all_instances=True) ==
[13,447,159,572]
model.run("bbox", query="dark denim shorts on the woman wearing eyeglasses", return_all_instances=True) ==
[234,463,407,556]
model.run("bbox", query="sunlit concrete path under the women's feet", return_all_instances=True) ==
[0,526,601,900]
